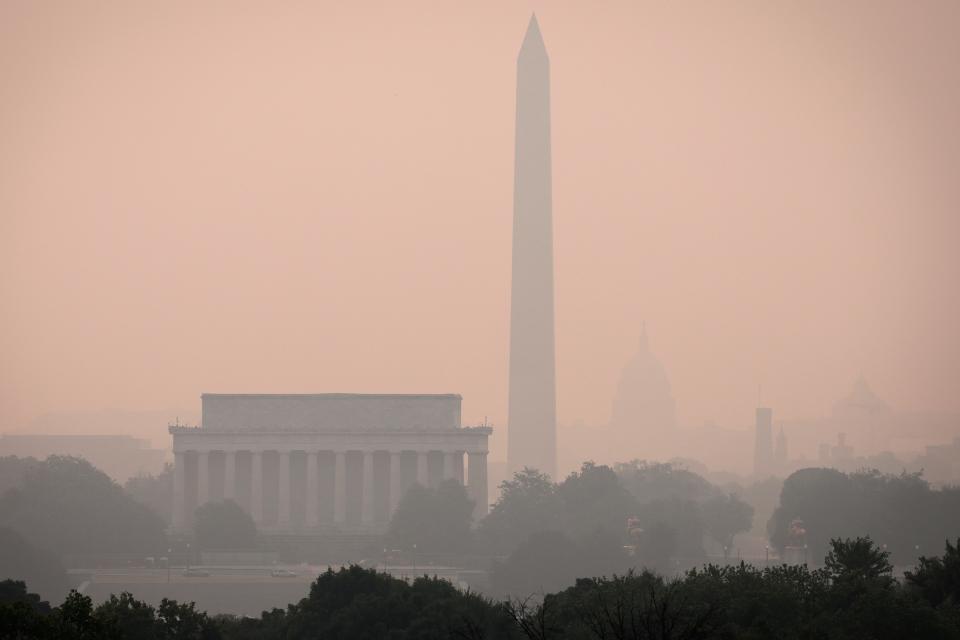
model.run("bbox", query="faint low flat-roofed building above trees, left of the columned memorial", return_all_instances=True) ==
[0,434,167,483]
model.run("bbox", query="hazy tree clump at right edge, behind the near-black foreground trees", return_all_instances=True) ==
[768,468,960,564]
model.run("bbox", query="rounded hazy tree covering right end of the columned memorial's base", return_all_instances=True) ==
[387,480,473,553]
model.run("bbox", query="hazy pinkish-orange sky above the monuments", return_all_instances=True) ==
[0,0,960,458]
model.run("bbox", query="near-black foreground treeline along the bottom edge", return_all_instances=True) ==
[0,538,960,640]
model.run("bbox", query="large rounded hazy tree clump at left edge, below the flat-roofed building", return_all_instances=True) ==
[0,456,166,554]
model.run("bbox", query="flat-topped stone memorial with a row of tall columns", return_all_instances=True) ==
[170,393,491,535]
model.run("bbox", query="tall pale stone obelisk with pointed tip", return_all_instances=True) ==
[507,16,557,477]
